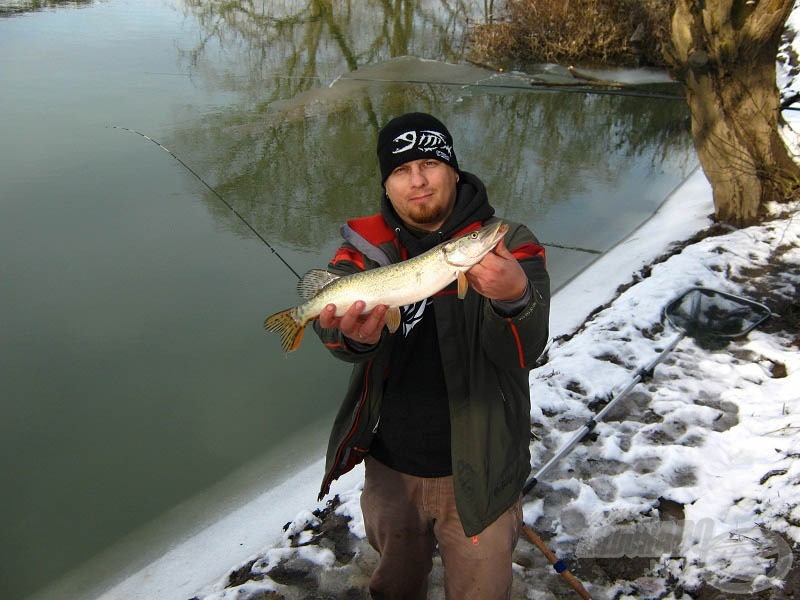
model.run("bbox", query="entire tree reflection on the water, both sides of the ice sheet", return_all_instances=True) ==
[174,0,695,260]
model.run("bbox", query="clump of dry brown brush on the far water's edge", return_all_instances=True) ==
[470,0,672,66]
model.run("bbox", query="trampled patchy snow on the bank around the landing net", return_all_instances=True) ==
[525,200,800,586]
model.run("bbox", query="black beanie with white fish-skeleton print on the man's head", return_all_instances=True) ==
[378,113,458,183]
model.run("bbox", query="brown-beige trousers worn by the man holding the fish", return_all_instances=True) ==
[361,458,522,600]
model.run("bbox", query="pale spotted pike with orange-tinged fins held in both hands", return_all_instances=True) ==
[264,221,508,352]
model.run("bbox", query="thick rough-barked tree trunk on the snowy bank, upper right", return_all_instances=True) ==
[665,0,800,226]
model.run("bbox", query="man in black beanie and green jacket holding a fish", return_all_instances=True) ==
[314,113,550,599]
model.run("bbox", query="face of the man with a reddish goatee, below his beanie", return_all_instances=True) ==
[383,158,458,231]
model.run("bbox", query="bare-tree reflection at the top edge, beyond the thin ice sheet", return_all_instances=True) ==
[184,0,483,91]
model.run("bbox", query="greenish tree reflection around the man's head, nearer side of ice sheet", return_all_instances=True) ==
[172,59,693,264]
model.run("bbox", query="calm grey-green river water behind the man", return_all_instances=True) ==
[0,0,697,598]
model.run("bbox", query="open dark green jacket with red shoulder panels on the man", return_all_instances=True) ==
[314,189,550,536]
